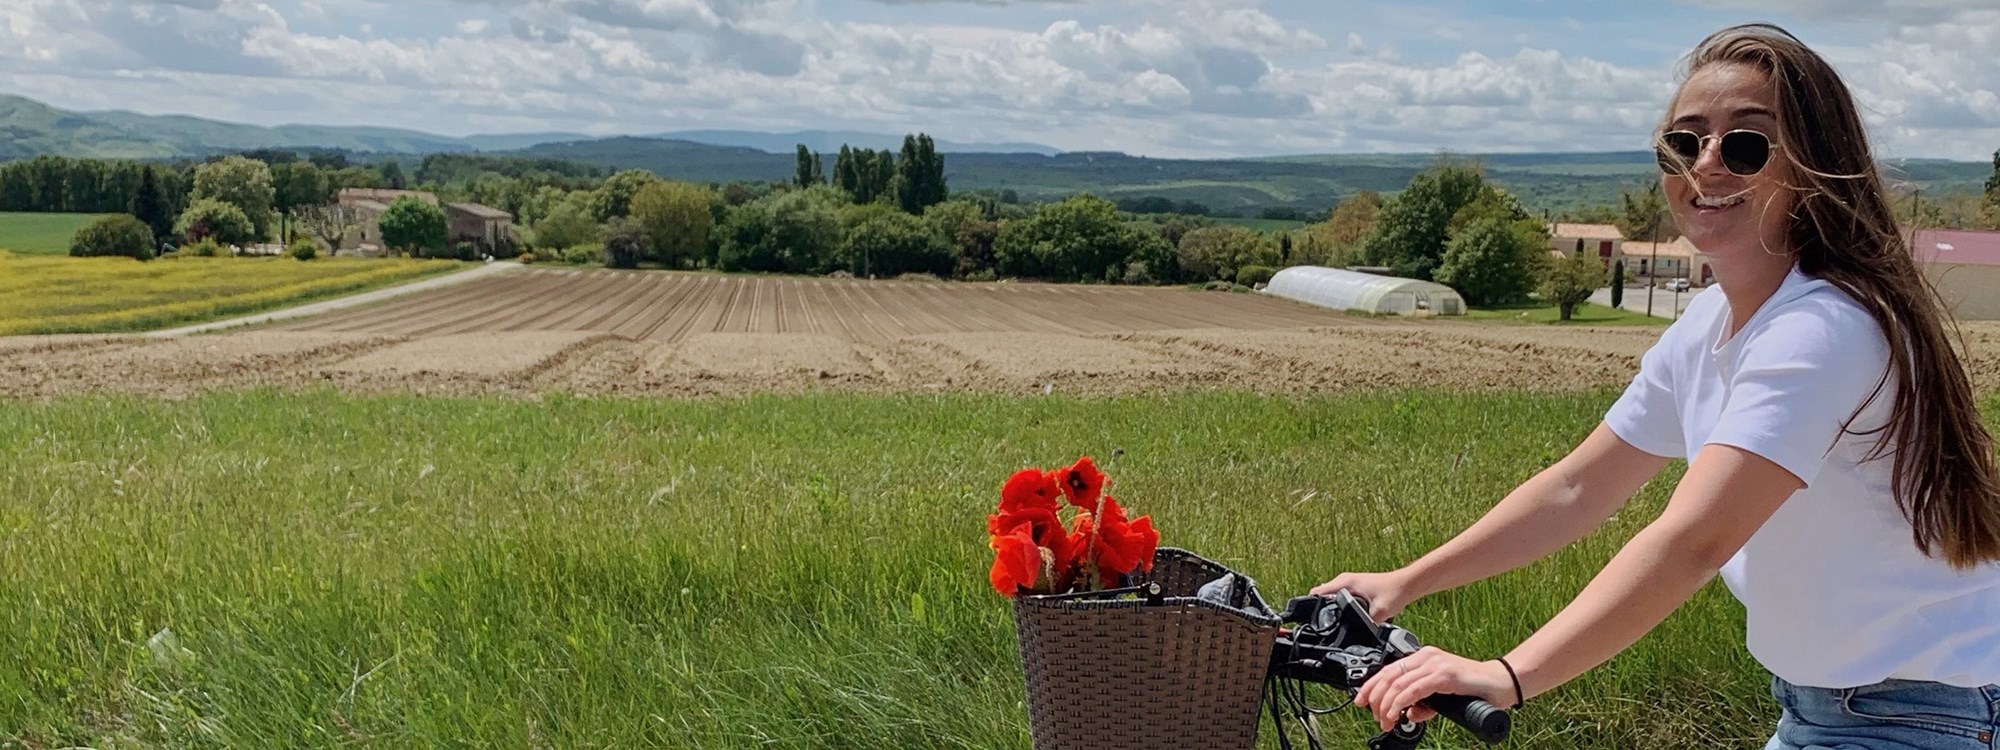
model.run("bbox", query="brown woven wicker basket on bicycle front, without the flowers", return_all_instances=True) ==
[1014,548,1278,750]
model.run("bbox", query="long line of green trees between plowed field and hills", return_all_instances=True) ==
[31,141,2000,314]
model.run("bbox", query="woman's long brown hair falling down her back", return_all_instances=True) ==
[1668,24,2000,570]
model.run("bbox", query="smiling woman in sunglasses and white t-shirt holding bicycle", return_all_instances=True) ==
[1314,24,2000,750]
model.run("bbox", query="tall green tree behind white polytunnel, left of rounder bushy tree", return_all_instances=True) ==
[1362,162,1486,280]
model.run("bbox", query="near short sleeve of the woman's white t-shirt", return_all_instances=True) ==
[1708,298,1888,486]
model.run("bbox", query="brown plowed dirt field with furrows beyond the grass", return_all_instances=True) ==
[0,268,2000,398]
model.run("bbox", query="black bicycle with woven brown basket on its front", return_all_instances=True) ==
[1014,548,1512,750]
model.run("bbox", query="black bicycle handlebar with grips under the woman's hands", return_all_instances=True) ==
[1270,590,1512,744]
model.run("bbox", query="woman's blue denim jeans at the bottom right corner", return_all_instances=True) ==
[1764,676,2000,750]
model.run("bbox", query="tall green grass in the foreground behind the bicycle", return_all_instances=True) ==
[0,392,1920,748]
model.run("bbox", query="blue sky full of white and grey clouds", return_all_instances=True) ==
[0,0,2000,160]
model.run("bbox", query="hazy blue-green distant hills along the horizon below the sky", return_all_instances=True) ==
[0,94,1992,216]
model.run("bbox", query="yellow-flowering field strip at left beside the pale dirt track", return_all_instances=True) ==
[0,252,466,336]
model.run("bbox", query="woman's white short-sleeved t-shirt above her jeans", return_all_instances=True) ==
[1604,266,2000,688]
